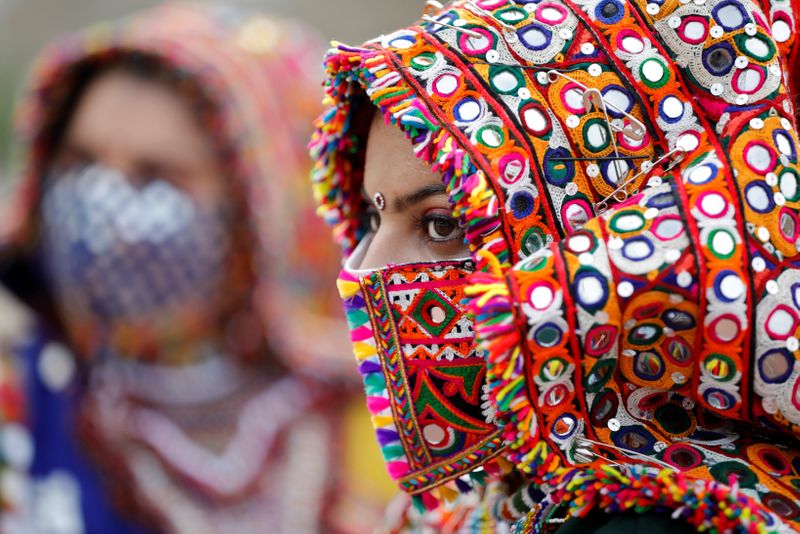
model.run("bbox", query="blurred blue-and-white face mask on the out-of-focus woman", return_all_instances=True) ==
[41,165,227,357]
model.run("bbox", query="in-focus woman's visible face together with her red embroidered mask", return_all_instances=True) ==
[339,110,500,493]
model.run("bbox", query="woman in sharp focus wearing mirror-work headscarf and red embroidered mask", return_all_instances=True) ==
[312,0,800,532]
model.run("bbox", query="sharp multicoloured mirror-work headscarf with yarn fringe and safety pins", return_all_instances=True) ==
[312,0,800,532]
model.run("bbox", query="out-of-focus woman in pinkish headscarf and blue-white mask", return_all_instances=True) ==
[0,4,388,533]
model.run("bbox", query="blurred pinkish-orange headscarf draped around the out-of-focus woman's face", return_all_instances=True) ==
[3,3,341,373]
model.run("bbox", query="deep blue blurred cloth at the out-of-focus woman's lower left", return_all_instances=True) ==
[18,329,150,534]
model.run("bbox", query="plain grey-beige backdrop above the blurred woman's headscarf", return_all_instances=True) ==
[0,0,424,180]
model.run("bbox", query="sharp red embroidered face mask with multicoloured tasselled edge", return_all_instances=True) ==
[338,238,501,494]
